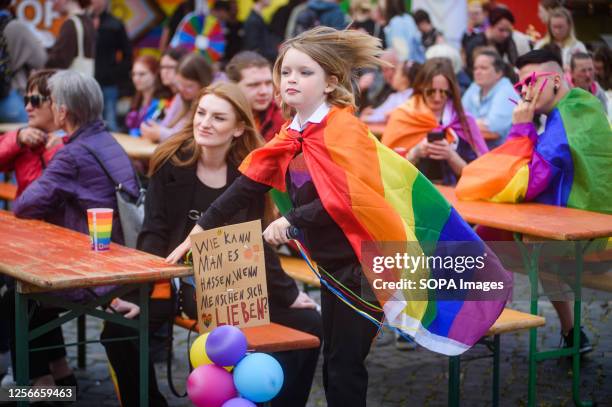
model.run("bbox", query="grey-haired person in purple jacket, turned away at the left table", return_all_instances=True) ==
[13,71,138,243]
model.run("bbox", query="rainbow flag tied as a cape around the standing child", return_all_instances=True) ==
[240,107,511,355]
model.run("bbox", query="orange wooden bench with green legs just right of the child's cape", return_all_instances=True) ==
[448,308,546,407]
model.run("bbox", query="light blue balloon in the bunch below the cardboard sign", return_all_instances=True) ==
[234,353,284,403]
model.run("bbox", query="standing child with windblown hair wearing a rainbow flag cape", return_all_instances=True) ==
[167,27,511,406]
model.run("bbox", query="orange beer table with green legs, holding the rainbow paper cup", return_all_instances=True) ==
[0,211,192,406]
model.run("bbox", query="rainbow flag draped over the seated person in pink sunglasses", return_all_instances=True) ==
[456,88,612,213]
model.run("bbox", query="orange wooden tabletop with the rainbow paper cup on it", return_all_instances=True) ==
[0,211,192,291]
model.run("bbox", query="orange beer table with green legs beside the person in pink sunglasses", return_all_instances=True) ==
[437,186,612,406]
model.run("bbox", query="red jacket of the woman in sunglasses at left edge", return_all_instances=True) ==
[0,131,64,196]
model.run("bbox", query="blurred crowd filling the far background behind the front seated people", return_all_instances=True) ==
[0,0,612,132]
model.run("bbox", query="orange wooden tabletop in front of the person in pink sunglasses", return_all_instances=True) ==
[438,186,612,240]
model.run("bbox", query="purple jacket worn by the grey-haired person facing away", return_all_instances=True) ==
[13,120,138,243]
